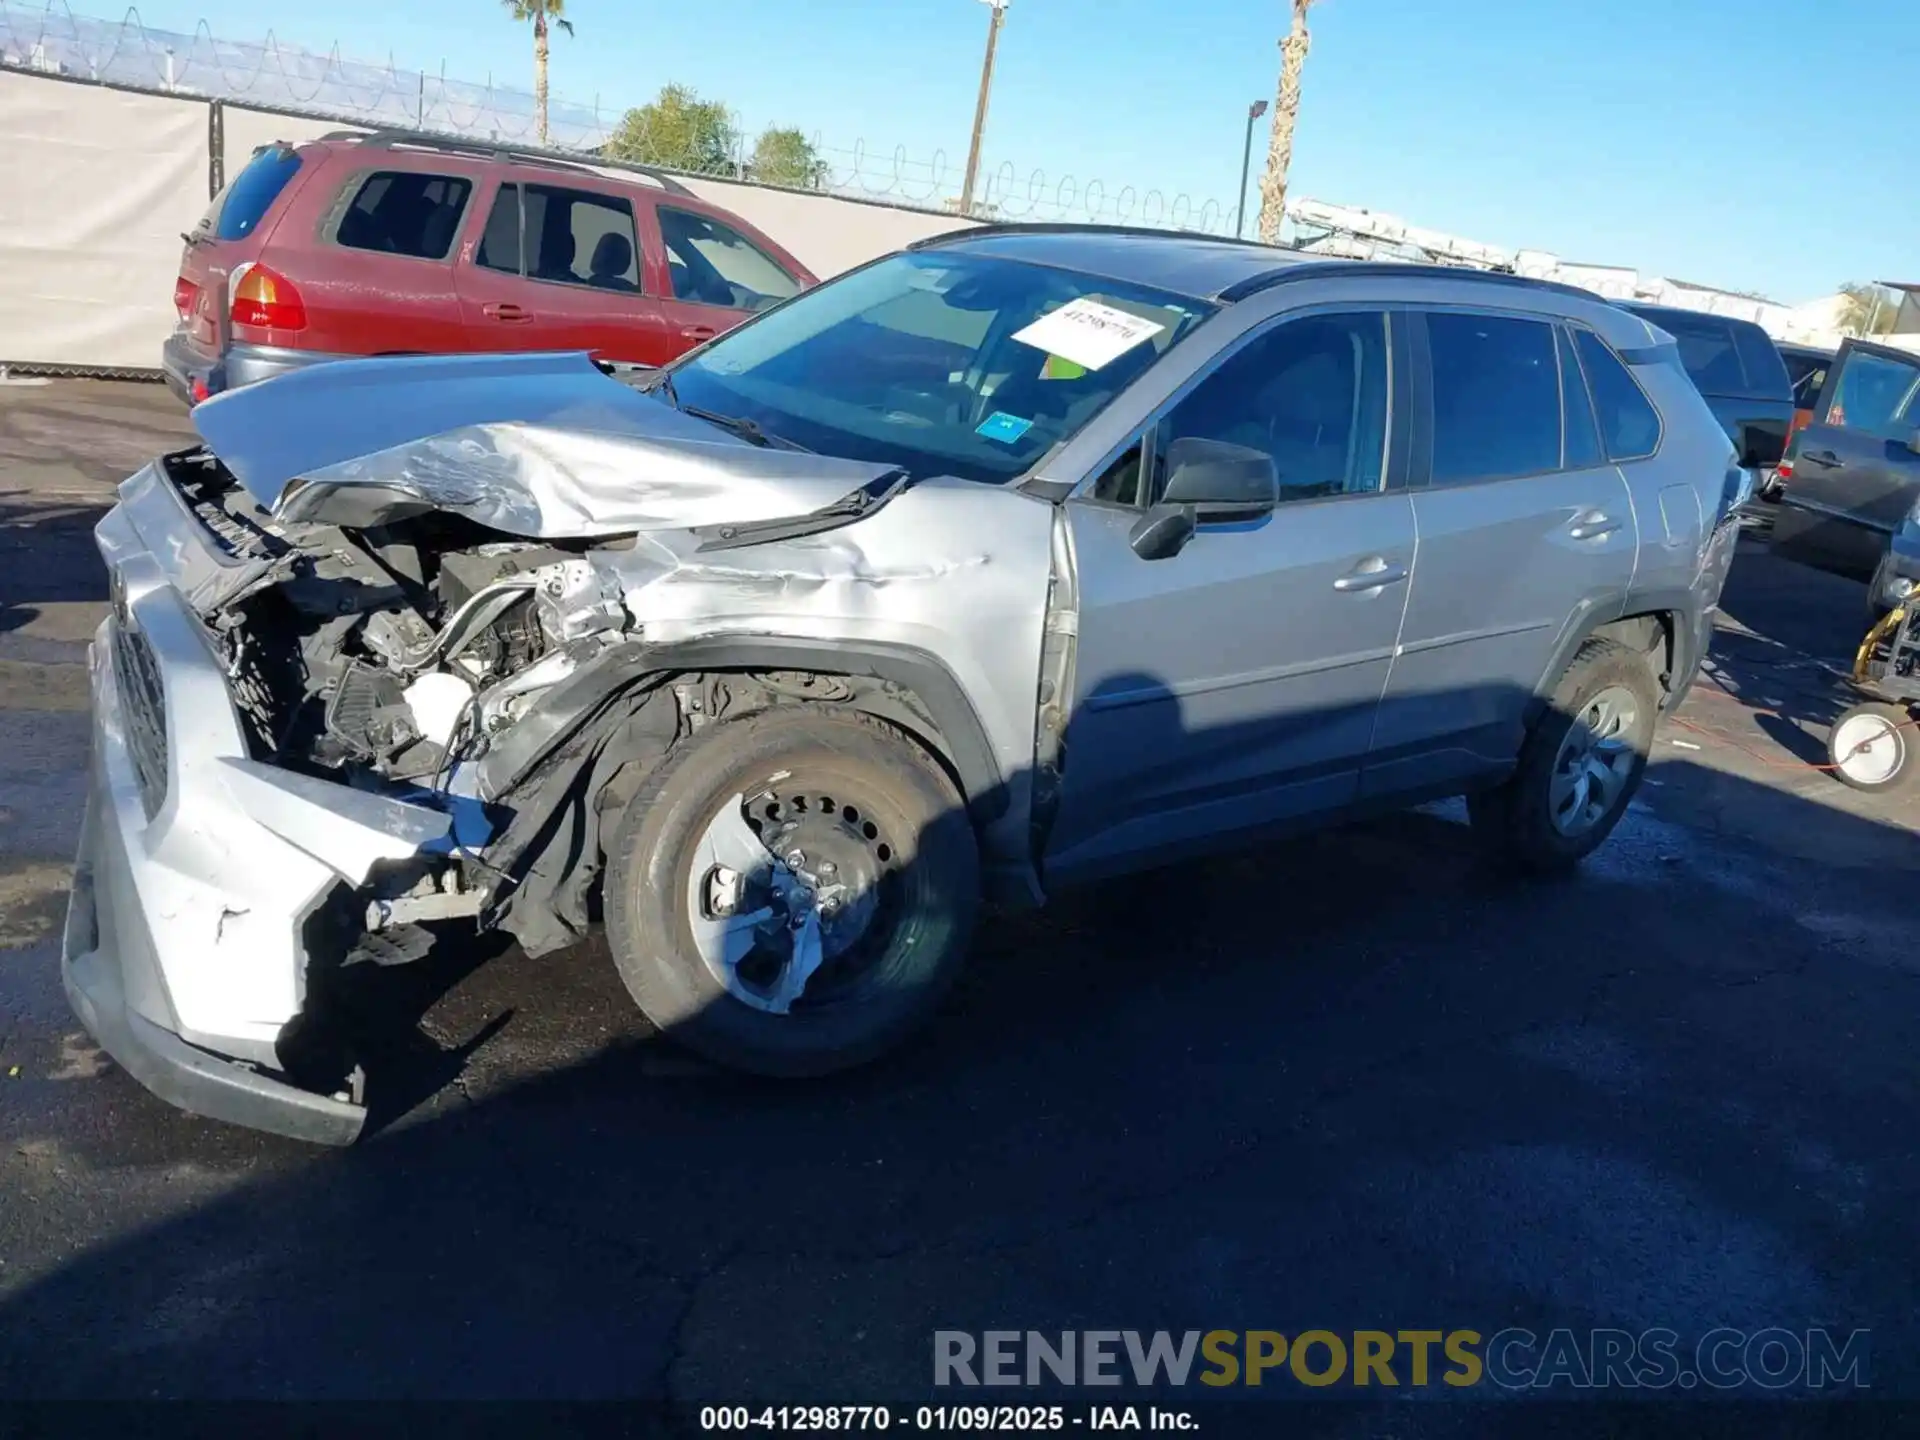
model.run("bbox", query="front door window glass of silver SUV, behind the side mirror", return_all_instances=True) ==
[1144,311,1388,503]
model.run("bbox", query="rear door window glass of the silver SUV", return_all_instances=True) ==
[1427,311,1561,486]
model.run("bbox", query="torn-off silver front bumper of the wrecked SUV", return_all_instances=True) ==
[61,491,460,1144]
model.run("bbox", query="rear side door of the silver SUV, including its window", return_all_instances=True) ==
[1363,309,1638,797]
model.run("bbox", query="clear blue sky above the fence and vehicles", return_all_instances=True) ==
[75,0,1920,301]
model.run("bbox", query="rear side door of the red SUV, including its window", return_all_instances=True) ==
[457,171,684,365]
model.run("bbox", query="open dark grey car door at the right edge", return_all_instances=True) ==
[1774,340,1920,580]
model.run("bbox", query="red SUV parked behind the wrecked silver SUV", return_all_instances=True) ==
[161,132,816,405]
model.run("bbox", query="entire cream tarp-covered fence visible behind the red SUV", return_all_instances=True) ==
[0,69,968,371]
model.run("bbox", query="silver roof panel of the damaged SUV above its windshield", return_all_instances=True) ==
[914,225,1331,300]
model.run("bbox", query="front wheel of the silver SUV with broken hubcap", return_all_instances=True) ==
[605,705,979,1075]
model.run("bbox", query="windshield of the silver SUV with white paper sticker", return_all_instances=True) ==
[672,250,1212,482]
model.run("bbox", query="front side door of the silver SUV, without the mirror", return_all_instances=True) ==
[1046,309,1415,881]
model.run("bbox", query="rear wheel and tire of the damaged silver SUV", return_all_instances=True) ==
[1467,637,1661,874]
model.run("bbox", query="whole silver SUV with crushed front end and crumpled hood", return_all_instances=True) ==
[63,227,1747,1142]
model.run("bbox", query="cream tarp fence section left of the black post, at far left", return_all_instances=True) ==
[0,71,207,369]
